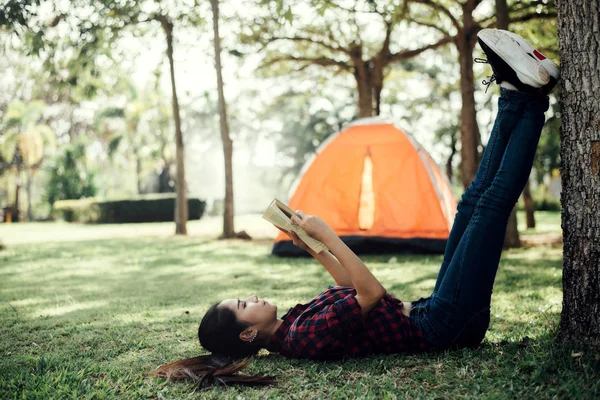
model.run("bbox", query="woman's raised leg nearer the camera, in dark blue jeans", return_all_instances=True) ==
[427,89,548,348]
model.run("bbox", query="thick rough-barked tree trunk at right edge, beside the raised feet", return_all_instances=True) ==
[557,0,600,346]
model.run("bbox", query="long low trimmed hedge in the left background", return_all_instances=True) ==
[53,193,206,223]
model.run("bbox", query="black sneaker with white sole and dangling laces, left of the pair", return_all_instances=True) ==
[477,29,550,94]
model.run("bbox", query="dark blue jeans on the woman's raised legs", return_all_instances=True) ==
[410,88,548,349]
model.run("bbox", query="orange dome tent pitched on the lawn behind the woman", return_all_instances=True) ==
[273,117,456,256]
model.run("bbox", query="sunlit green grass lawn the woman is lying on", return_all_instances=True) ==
[0,213,600,399]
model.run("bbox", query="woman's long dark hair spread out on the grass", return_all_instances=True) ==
[153,303,275,388]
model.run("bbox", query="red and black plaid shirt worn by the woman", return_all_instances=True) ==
[267,286,425,359]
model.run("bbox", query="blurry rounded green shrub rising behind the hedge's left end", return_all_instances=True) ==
[46,143,98,205]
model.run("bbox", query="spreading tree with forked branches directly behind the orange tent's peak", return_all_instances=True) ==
[244,0,450,118]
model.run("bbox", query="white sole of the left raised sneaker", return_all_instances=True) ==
[477,29,550,88]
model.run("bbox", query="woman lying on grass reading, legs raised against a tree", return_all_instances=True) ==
[157,29,559,383]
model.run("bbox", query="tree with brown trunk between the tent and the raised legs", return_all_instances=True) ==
[409,0,556,188]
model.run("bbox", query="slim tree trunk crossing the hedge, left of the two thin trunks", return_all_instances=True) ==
[157,16,188,235]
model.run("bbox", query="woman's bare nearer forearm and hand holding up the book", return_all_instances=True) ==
[292,211,386,318]
